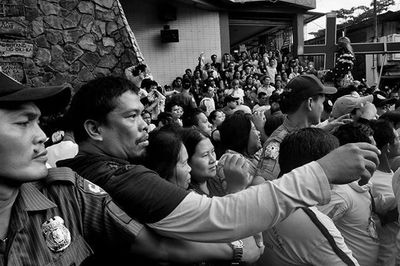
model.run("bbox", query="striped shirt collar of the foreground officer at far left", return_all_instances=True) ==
[20,183,57,211]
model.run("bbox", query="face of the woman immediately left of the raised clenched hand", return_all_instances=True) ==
[189,138,217,183]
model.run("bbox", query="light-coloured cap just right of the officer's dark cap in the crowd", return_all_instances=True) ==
[331,94,374,118]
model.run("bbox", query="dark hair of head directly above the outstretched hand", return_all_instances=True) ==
[333,123,374,145]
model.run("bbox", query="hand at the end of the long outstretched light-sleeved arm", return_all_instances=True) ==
[317,143,380,184]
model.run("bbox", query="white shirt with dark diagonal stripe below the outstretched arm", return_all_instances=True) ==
[256,207,359,266]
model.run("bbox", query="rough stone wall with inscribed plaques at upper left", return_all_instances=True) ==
[0,0,143,89]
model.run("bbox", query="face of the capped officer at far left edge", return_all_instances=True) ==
[0,103,47,184]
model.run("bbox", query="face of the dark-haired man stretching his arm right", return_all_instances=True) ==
[99,91,149,160]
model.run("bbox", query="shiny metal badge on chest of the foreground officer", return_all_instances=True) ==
[42,216,71,252]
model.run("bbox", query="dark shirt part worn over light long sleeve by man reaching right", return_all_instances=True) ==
[57,153,189,224]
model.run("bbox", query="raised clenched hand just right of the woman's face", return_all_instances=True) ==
[224,154,252,193]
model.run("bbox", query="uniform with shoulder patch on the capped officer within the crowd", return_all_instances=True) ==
[254,117,298,180]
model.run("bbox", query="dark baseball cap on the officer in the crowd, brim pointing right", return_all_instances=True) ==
[286,74,337,98]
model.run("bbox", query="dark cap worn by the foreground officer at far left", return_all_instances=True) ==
[0,71,71,114]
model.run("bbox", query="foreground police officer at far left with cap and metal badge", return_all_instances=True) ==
[0,71,260,265]
